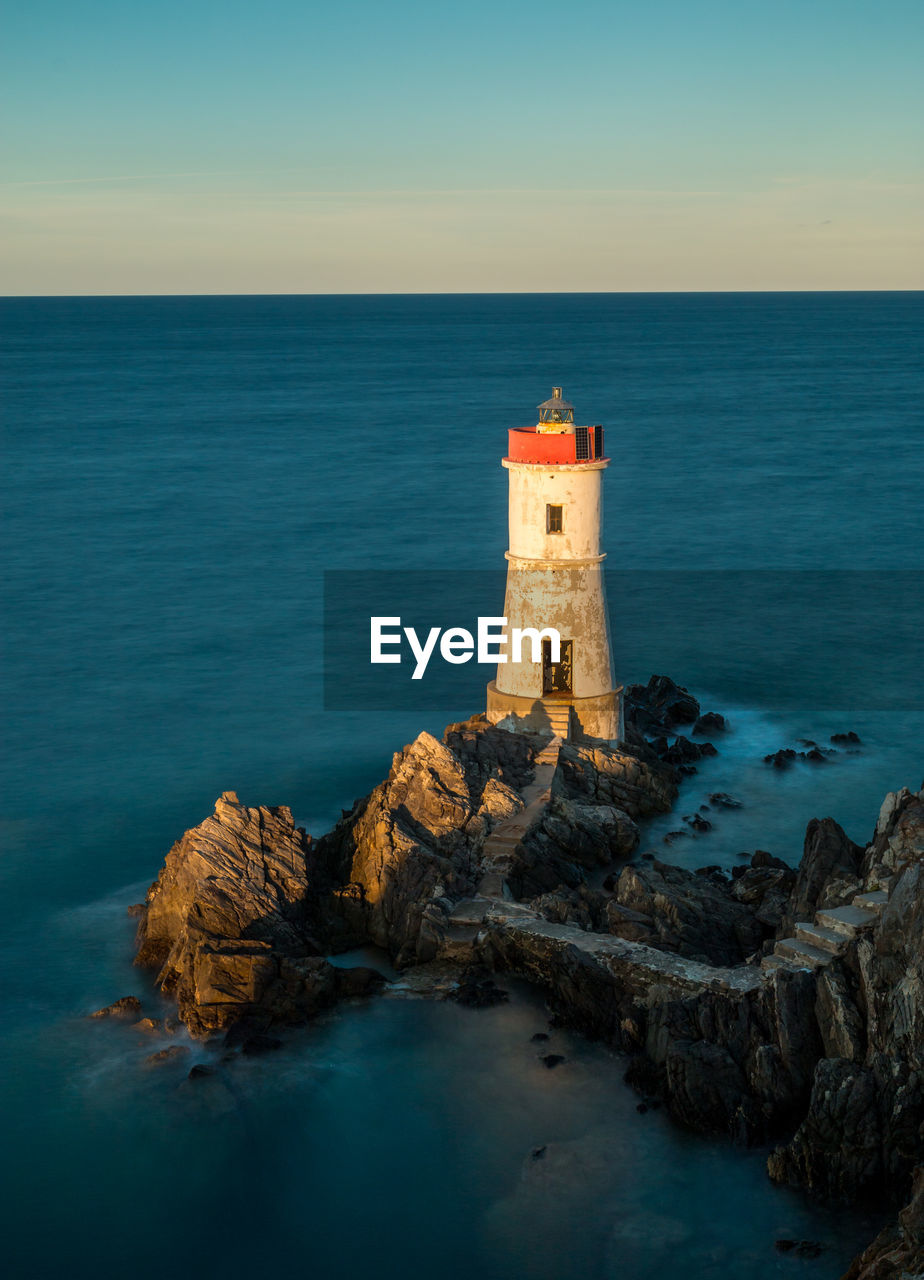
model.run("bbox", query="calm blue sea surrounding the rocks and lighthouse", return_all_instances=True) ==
[0,293,924,1280]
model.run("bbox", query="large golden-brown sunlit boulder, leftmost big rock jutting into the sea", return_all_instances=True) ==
[136,791,337,1036]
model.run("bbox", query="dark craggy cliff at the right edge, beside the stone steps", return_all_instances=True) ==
[769,790,924,1201]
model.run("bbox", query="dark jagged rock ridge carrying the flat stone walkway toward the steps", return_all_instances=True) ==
[482,906,820,1142]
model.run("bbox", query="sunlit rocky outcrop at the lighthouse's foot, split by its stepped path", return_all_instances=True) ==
[317,718,677,966]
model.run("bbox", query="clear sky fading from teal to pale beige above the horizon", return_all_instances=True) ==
[0,0,924,294]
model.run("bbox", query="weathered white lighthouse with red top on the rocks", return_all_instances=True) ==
[488,387,622,741]
